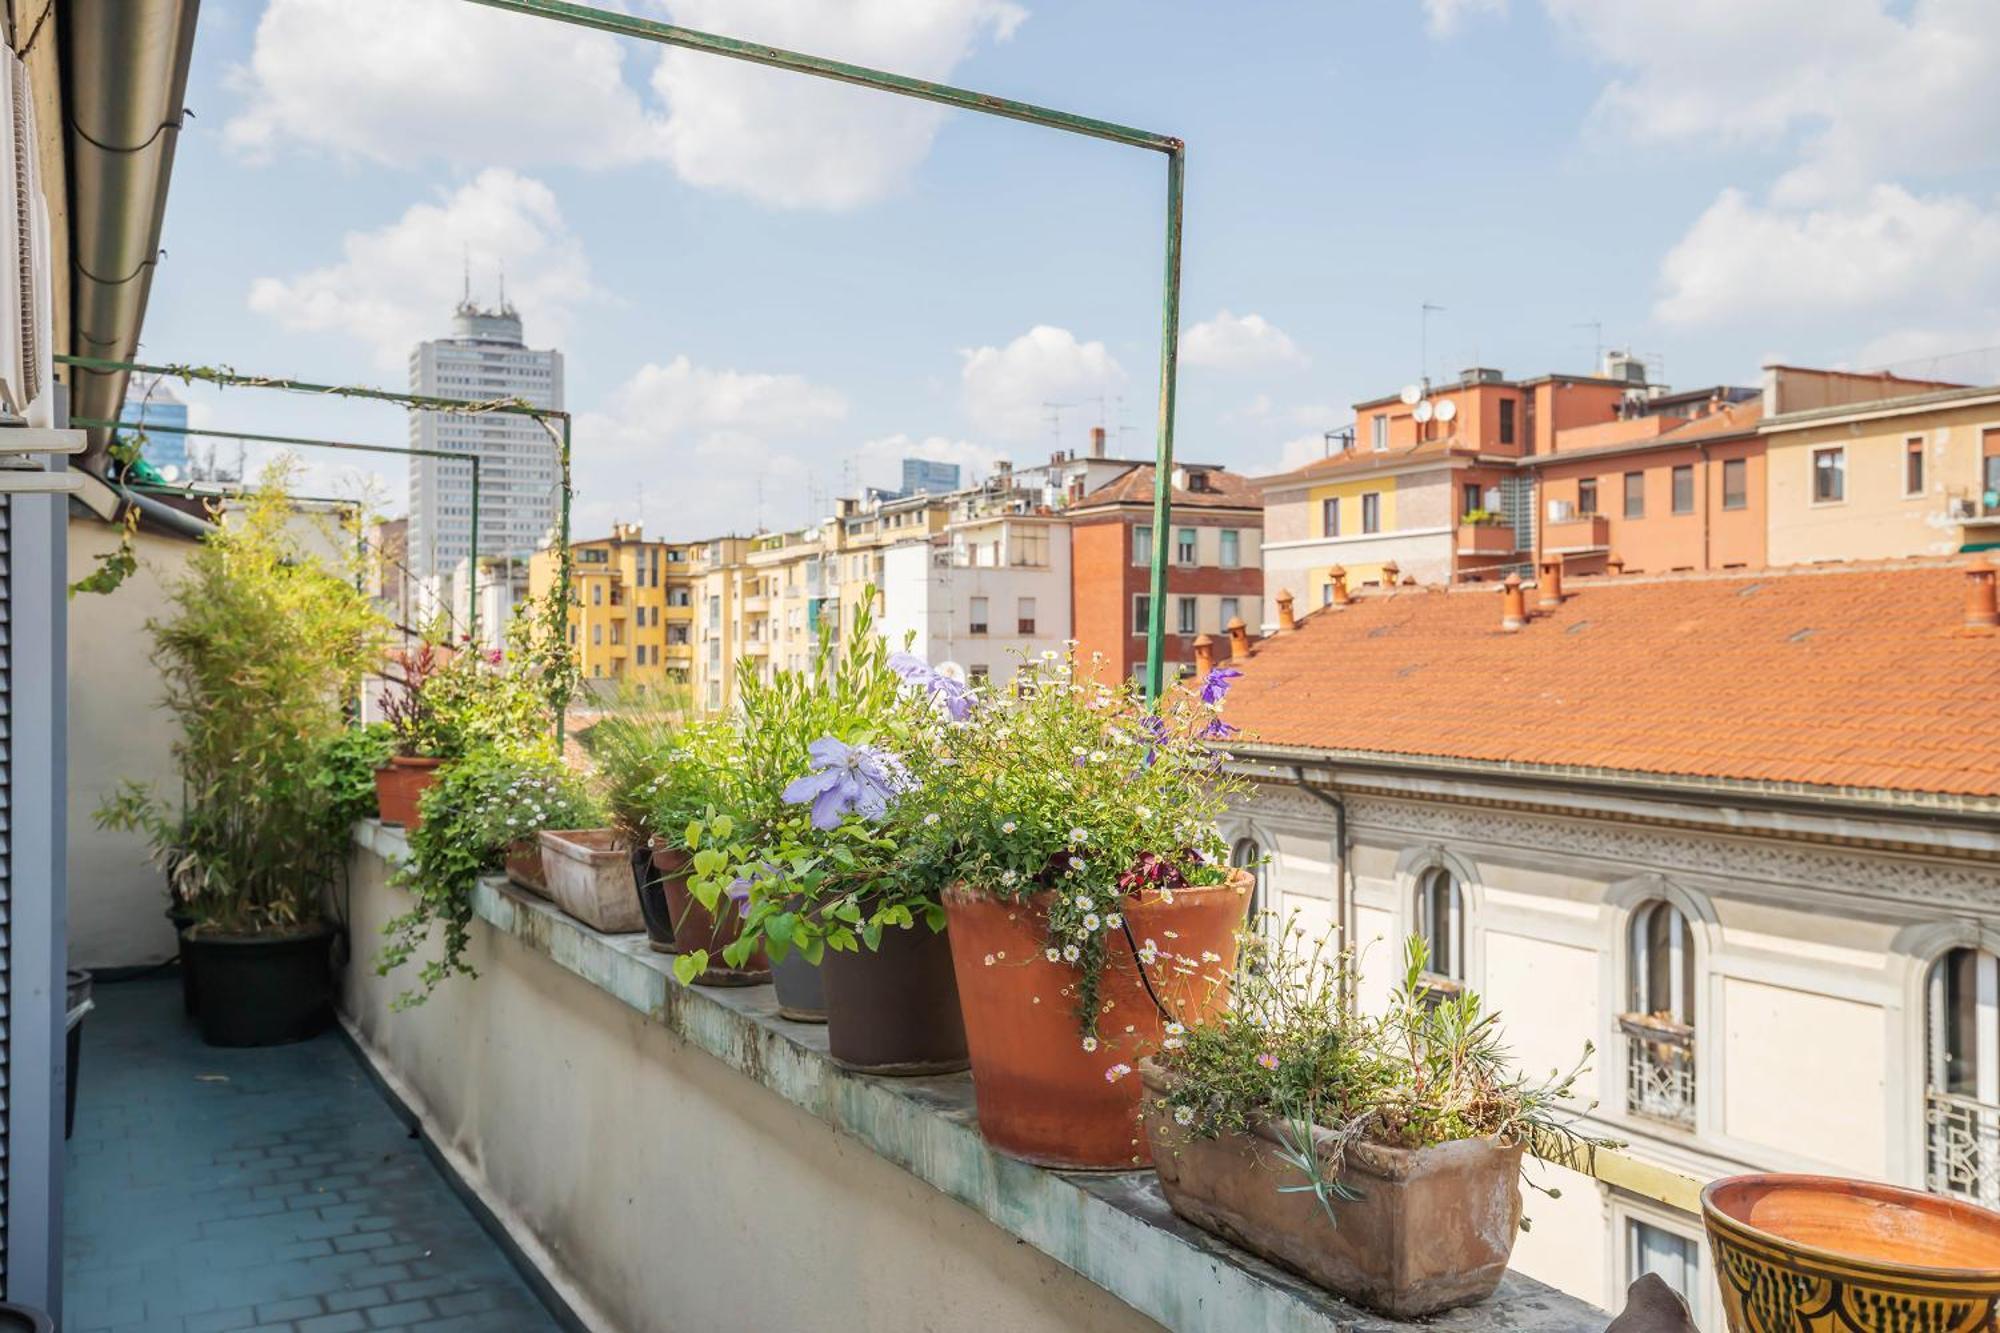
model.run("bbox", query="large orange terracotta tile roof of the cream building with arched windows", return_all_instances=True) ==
[1226,562,2000,797]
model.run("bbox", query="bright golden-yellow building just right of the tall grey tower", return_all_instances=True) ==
[528,522,696,687]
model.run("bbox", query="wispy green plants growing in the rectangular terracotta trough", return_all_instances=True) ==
[1160,923,1610,1225]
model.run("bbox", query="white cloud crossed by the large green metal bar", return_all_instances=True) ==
[652,0,1026,208]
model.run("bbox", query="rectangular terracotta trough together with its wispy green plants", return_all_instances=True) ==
[1152,925,1600,1319]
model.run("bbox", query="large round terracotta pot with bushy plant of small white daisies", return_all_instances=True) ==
[910,652,1250,1169]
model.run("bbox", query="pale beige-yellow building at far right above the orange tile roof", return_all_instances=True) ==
[1764,376,2000,564]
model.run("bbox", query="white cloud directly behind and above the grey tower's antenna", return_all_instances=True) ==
[250,168,598,368]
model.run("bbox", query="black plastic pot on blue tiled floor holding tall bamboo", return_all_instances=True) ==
[180,925,334,1047]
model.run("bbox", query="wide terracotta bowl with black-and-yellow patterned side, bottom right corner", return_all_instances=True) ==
[1702,1175,2000,1333]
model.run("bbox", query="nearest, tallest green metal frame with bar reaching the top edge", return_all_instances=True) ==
[470,0,1188,701]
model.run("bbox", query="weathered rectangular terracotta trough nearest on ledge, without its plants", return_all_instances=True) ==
[1134,1061,1520,1319]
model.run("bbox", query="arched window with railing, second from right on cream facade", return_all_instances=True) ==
[1618,899,1694,1129]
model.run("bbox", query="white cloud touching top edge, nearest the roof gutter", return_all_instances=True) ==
[224,0,664,166]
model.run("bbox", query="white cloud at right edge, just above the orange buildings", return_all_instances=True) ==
[1656,184,2000,324]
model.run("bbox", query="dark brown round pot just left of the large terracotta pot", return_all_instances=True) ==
[820,925,970,1077]
